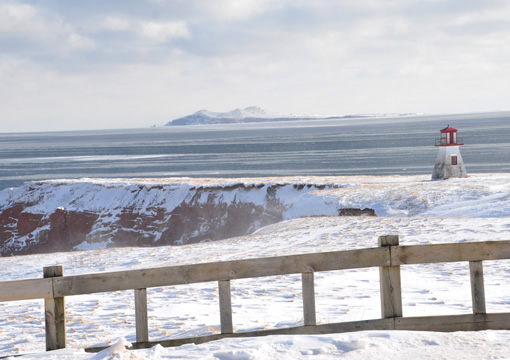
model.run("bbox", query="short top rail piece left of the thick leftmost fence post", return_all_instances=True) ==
[0,279,53,301]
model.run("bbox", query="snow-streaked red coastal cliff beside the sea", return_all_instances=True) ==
[0,179,346,256]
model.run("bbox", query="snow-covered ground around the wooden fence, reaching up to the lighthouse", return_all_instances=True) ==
[0,174,510,360]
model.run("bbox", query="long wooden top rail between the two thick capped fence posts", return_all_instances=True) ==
[54,248,390,296]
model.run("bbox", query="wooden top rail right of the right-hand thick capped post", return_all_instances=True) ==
[391,240,510,265]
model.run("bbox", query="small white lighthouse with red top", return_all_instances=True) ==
[432,125,467,180]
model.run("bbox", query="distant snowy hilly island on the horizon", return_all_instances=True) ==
[165,106,417,126]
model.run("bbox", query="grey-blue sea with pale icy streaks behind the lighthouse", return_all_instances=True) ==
[0,112,510,190]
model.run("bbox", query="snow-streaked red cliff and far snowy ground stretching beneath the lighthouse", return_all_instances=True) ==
[0,174,510,256]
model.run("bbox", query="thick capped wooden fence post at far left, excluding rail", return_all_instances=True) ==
[43,265,66,351]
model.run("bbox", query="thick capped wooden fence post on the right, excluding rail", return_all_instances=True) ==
[379,235,402,318]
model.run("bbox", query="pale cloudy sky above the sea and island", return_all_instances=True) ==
[0,0,510,132]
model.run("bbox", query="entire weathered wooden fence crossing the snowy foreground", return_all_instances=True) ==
[0,235,510,351]
